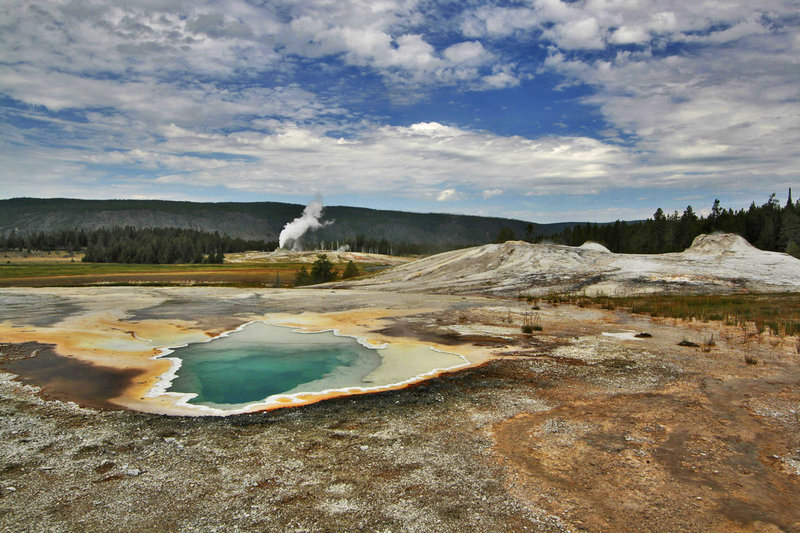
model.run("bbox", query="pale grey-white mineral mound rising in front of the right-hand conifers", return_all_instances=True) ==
[338,234,800,296]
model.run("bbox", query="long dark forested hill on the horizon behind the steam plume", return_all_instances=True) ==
[0,198,572,248]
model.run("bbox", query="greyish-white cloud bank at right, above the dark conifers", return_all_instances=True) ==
[547,23,800,187]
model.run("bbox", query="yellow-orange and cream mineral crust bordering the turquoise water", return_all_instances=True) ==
[0,291,492,415]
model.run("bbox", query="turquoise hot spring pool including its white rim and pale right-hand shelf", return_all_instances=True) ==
[151,322,468,412]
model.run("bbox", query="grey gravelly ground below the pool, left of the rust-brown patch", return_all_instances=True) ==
[0,369,564,532]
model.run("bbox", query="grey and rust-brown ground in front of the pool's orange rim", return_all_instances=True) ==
[0,301,800,532]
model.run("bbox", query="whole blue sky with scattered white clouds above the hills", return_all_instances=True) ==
[0,0,800,222]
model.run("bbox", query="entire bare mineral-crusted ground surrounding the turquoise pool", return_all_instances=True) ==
[0,235,800,532]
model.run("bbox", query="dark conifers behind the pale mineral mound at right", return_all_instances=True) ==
[495,189,800,258]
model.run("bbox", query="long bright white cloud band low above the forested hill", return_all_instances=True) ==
[0,112,630,201]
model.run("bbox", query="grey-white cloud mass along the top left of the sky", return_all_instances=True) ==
[0,0,520,109]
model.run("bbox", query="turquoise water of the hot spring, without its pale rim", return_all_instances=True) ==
[169,322,381,407]
